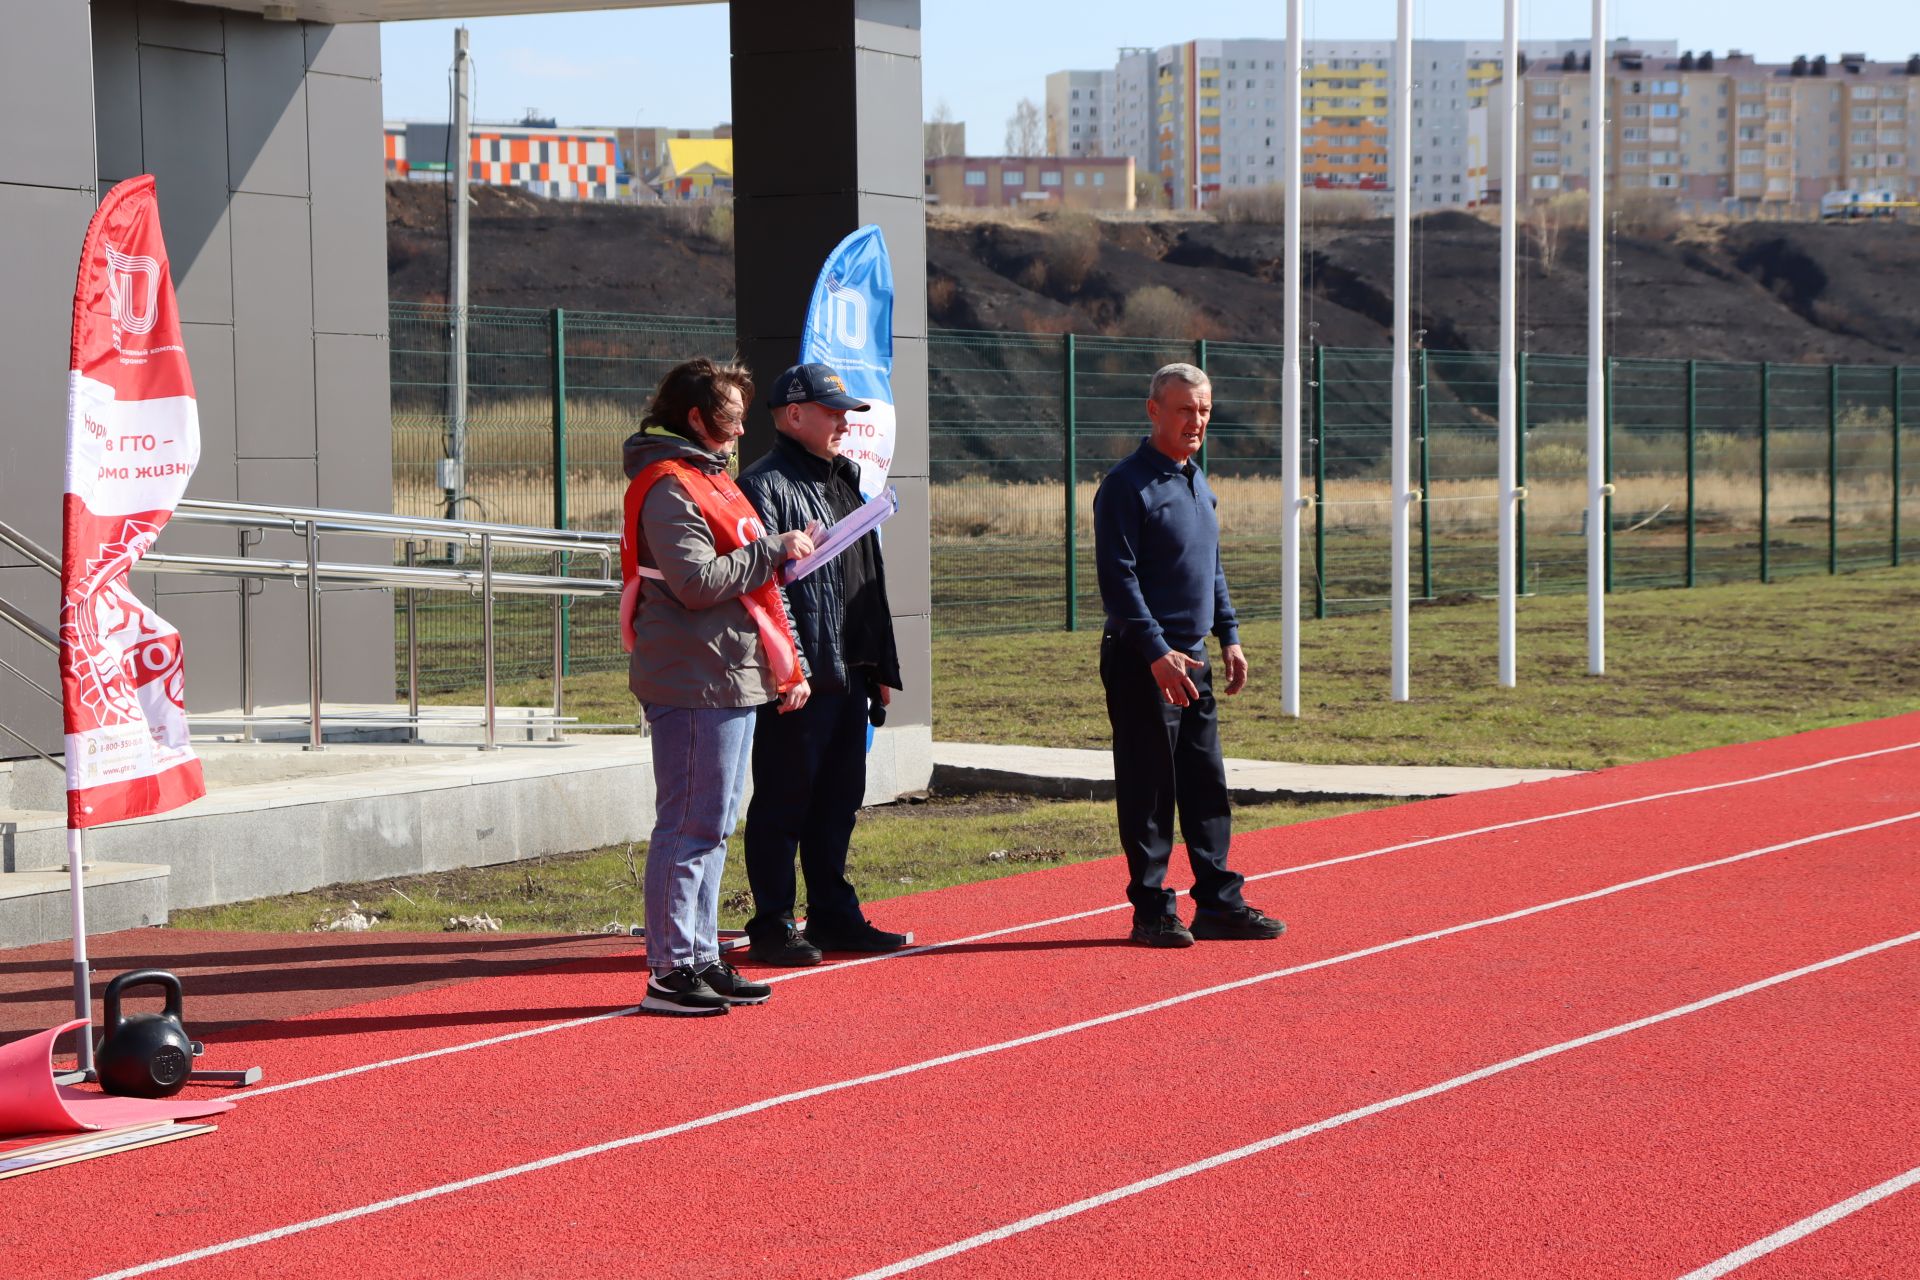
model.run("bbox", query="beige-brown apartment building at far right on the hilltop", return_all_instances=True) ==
[1494,50,1920,213]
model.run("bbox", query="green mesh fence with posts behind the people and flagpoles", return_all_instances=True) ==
[392,303,1920,689]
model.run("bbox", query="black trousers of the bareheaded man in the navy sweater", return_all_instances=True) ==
[1105,637,1244,921]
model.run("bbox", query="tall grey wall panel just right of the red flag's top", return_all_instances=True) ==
[140,45,234,324]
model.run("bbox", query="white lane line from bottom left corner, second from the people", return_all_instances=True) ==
[96,810,1920,1280]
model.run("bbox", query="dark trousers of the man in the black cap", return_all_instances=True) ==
[747,693,866,938]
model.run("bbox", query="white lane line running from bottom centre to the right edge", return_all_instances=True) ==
[852,933,1920,1280]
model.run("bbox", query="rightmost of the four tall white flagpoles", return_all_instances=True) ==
[1586,0,1607,676]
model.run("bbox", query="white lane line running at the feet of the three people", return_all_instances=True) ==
[228,743,1920,1102]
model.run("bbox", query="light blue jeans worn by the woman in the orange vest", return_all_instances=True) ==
[645,706,755,973]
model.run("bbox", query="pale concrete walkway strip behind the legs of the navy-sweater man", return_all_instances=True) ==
[933,743,1571,804]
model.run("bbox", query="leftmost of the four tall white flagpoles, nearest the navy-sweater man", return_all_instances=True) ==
[1281,0,1304,716]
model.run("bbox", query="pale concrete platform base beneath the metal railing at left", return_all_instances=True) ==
[0,725,933,946]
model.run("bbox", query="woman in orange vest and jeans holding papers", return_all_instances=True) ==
[620,357,814,1015]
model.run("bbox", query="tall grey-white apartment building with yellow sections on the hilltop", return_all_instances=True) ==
[1046,40,1678,209]
